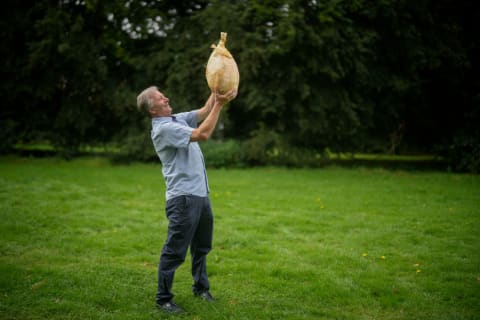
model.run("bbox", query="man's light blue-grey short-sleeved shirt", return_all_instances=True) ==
[151,111,209,200]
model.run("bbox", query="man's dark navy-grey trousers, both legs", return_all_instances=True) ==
[156,195,213,304]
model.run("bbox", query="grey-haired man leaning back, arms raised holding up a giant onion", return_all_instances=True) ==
[137,86,237,313]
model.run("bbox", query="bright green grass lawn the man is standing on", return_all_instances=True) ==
[0,157,480,320]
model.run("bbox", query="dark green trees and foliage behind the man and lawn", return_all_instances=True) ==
[0,0,480,171]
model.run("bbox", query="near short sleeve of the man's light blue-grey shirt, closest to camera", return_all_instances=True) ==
[152,122,193,151]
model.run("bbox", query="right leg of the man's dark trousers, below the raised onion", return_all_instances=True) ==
[190,197,213,293]
